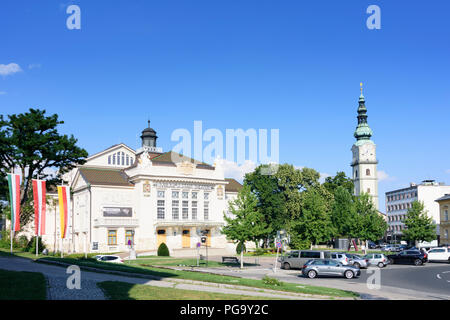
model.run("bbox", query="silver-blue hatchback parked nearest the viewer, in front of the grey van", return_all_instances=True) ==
[302,259,361,279]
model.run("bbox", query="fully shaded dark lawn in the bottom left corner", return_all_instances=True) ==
[0,269,47,300]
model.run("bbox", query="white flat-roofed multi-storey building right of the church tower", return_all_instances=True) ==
[386,180,450,235]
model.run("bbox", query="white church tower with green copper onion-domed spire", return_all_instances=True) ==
[351,83,378,210]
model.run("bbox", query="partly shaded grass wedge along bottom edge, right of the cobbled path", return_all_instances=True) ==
[97,281,273,300]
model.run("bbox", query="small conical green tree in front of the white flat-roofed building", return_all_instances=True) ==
[403,201,436,246]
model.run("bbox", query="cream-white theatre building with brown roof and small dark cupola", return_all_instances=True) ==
[44,122,242,254]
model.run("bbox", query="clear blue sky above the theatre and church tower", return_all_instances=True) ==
[0,0,450,210]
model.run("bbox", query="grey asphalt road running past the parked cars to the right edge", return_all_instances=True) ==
[201,258,450,300]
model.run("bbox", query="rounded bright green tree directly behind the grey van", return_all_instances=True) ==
[291,188,335,249]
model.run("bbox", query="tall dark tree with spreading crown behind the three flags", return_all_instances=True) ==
[0,109,88,225]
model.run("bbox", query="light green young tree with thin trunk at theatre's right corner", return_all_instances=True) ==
[222,184,270,268]
